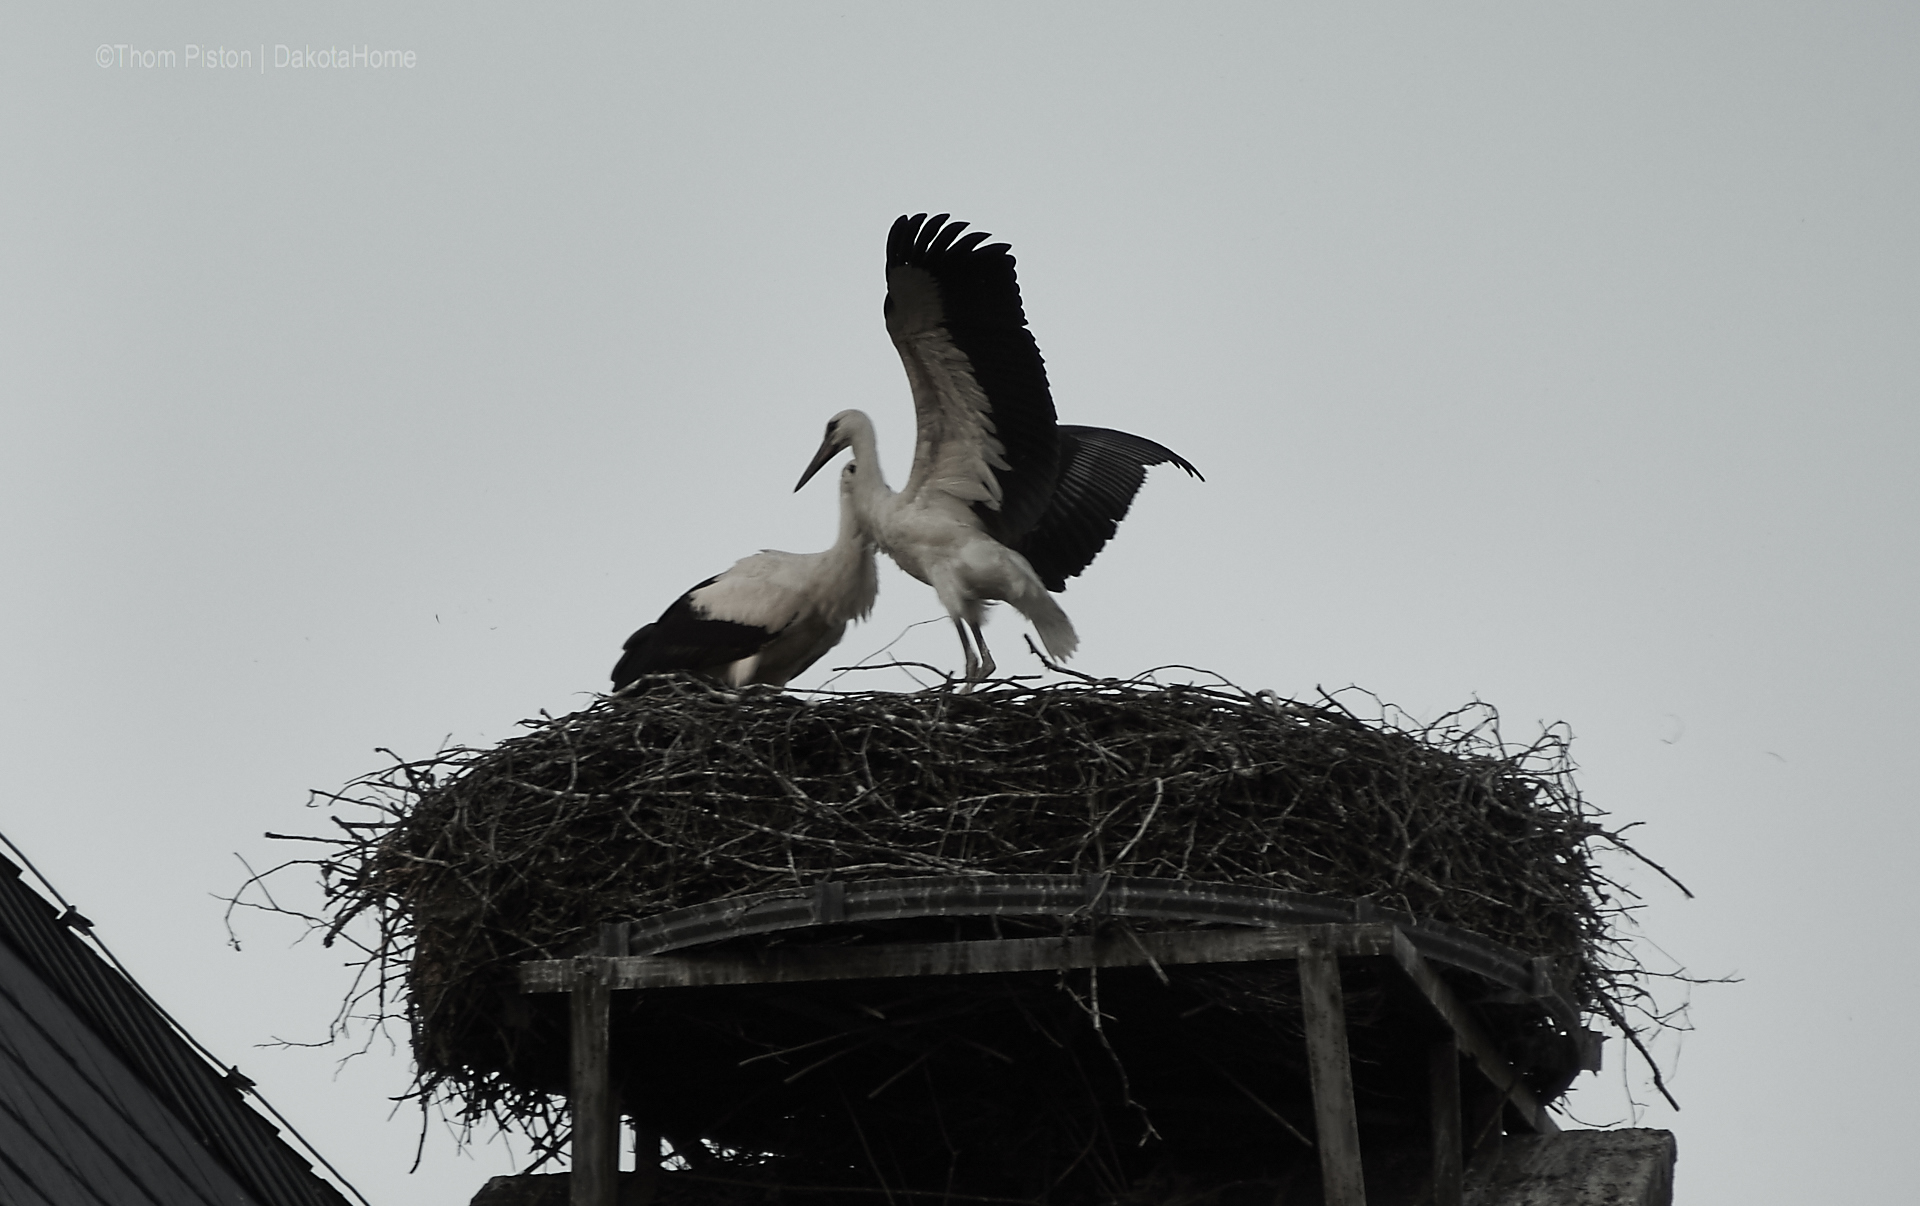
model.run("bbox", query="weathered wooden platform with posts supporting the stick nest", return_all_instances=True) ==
[520,876,1599,1206]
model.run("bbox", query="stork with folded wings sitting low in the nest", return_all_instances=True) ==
[612,461,879,691]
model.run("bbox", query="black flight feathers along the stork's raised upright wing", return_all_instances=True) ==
[887,213,1060,542]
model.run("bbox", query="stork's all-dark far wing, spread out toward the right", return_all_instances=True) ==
[1012,426,1204,591]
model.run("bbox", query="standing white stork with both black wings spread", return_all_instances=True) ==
[795,213,1200,682]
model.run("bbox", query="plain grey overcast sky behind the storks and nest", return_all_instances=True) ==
[0,2,1920,1206]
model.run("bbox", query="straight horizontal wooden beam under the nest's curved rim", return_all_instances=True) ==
[520,924,1394,993]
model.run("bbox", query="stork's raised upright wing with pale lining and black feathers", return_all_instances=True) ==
[887,213,1058,542]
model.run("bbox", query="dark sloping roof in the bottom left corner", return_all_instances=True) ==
[0,856,346,1206]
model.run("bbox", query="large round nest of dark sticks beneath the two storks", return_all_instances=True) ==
[288,678,1681,1200]
